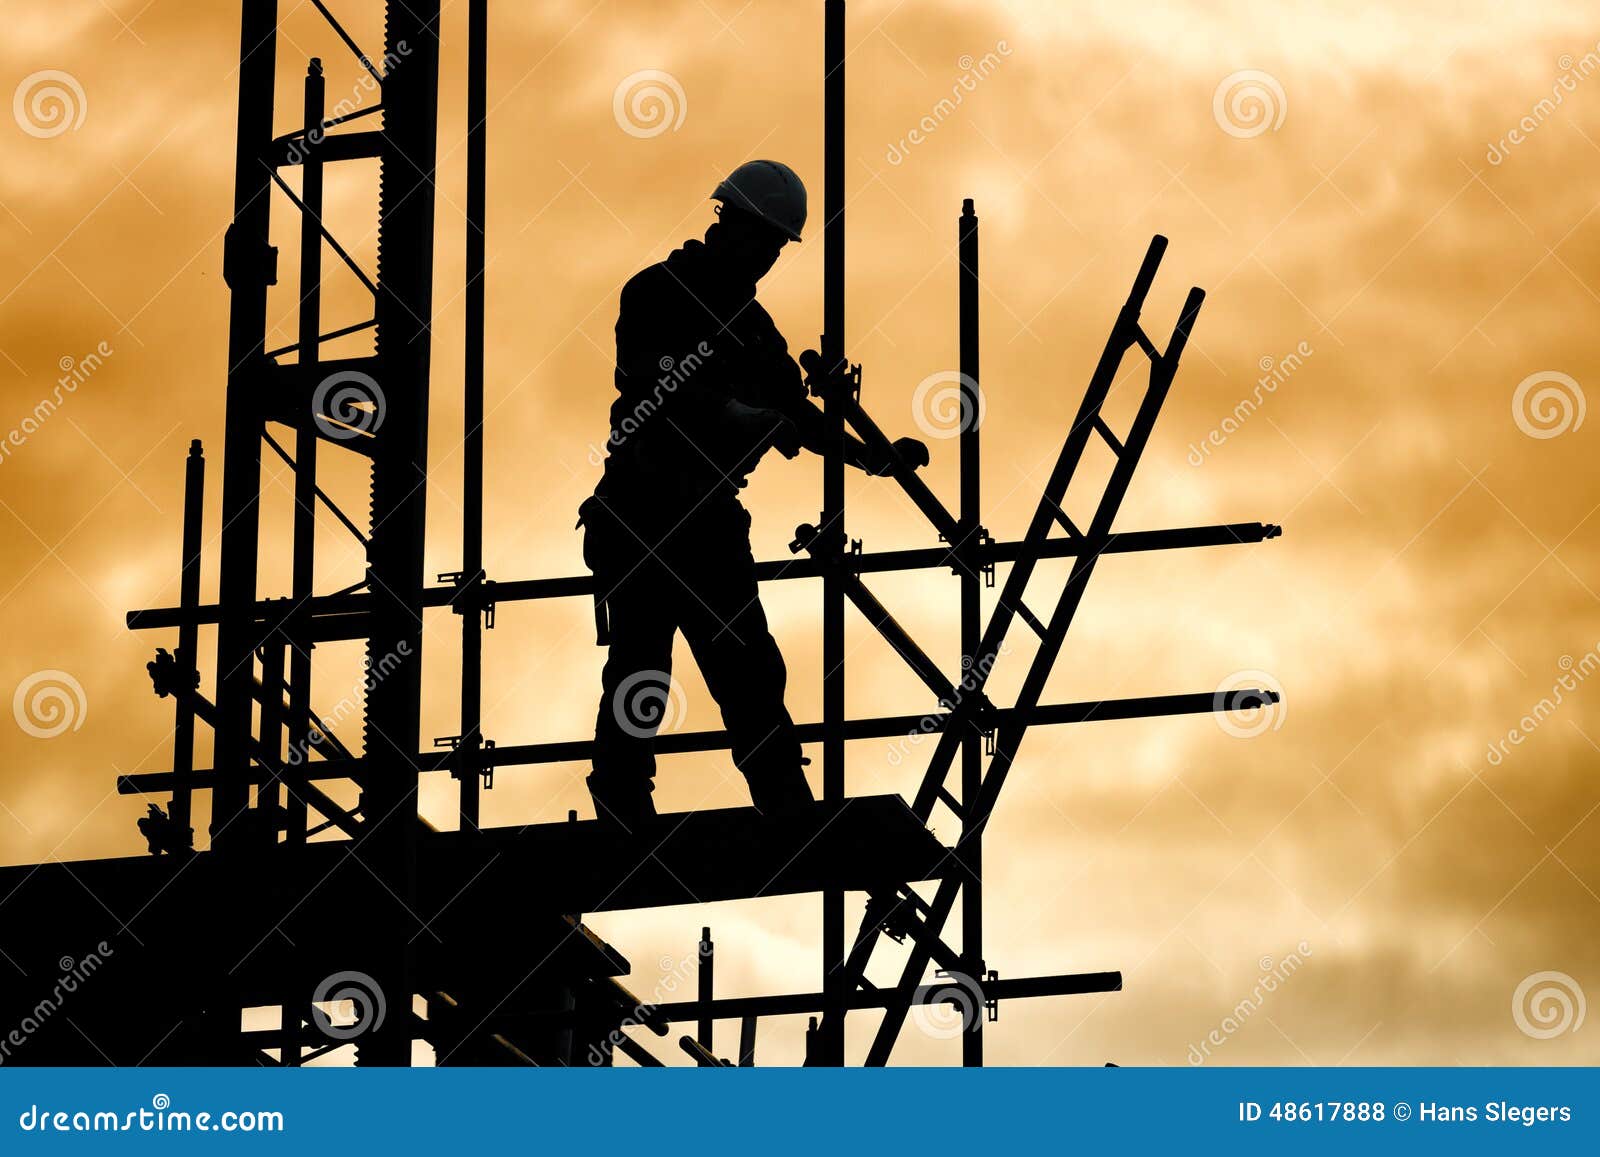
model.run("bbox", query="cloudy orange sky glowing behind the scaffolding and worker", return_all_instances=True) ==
[0,0,1600,1064]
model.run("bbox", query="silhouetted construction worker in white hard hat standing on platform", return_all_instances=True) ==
[579,160,928,827]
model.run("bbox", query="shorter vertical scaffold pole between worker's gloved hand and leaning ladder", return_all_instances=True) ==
[957,198,984,1067]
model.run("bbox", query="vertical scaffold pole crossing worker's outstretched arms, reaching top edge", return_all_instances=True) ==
[813,0,848,1066]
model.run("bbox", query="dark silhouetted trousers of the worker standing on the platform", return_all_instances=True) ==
[582,498,802,791]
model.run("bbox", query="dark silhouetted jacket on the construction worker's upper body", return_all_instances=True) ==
[602,242,814,514]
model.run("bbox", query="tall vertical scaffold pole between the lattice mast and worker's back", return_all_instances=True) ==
[456,0,488,832]
